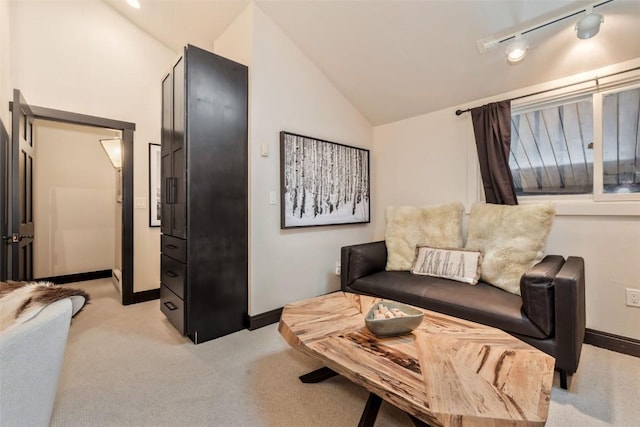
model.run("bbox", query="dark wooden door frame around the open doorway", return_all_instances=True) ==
[9,103,150,305]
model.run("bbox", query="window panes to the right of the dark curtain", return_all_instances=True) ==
[509,88,640,196]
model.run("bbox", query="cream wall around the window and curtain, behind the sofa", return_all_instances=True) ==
[373,59,640,339]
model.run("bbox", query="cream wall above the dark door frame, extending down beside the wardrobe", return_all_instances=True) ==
[10,0,177,292]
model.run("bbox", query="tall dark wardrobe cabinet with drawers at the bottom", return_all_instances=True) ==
[160,45,248,344]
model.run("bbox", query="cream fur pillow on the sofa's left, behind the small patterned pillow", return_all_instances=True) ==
[385,203,464,271]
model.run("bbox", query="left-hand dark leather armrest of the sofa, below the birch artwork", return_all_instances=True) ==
[340,241,387,291]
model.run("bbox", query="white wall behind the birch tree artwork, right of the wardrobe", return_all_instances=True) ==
[214,4,375,315]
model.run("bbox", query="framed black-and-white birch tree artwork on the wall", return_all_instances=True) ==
[280,131,370,229]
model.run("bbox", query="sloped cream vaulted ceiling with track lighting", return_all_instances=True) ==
[105,0,640,125]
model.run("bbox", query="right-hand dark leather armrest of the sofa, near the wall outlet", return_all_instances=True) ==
[554,257,586,374]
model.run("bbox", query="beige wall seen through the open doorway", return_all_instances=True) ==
[33,120,117,278]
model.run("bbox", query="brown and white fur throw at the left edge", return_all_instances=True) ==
[0,282,89,332]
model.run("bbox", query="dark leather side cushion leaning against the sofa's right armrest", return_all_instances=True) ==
[520,255,564,336]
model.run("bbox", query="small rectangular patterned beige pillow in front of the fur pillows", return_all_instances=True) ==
[411,246,482,285]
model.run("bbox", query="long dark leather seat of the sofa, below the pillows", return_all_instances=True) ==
[351,271,548,338]
